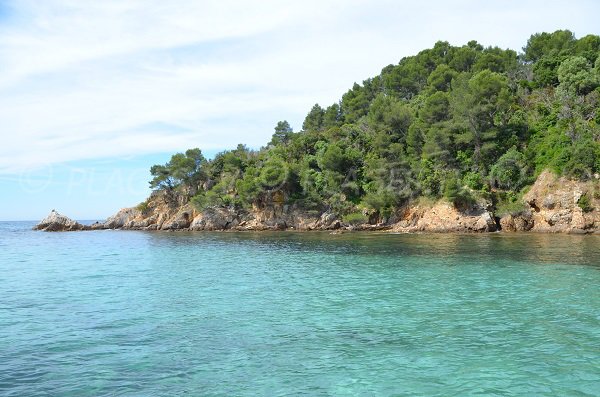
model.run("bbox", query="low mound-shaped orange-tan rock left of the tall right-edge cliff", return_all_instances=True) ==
[392,202,497,233]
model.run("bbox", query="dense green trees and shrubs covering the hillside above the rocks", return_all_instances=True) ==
[150,30,600,221]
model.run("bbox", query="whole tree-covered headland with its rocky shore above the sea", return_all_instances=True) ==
[34,34,600,233]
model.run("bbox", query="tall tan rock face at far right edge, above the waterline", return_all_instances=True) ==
[500,171,600,233]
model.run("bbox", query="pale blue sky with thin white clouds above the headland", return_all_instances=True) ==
[0,0,600,220]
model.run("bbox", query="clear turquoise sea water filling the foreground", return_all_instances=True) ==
[0,222,600,397]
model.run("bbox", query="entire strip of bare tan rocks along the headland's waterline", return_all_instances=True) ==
[34,171,600,234]
